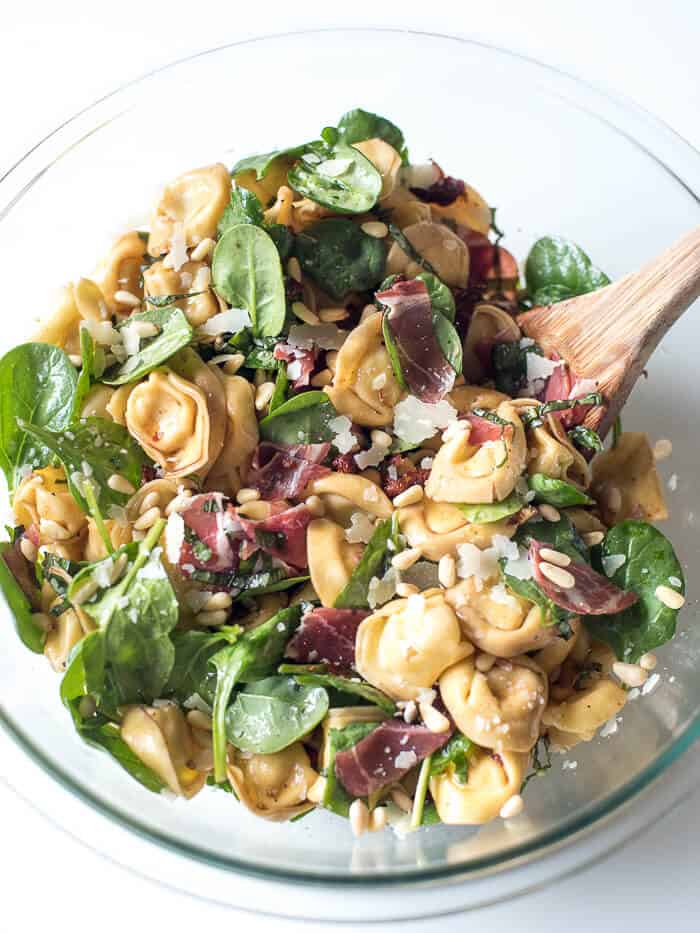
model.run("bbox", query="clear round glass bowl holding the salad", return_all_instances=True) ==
[0,29,700,919]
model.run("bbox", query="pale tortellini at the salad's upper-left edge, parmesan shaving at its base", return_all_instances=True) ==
[148,163,231,257]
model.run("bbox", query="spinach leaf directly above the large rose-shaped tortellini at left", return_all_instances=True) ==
[102,308,193,386]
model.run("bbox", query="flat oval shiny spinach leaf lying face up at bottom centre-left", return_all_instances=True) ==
[226,676,328,755]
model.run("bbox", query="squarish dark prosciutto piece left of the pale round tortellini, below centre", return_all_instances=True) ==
[287,608,370,669]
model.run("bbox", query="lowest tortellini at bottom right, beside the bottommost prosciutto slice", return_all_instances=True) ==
[430,748,528,826]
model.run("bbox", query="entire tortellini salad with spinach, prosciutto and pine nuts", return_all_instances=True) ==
[0,109,685,835]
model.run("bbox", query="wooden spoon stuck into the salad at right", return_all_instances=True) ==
[516,227,700,436]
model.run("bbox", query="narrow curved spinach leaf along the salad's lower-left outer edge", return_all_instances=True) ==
[61,631,165,794]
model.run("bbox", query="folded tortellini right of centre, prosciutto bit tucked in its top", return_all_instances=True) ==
[425,402,527,504]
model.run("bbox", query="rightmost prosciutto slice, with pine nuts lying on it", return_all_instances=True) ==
[530,540,639,616]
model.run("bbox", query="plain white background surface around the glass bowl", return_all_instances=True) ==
[0,0,700,933]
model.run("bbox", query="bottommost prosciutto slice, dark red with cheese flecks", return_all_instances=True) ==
[335,719,451,797]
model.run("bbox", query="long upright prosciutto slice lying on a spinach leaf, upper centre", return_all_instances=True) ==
[377,279,455,404]
